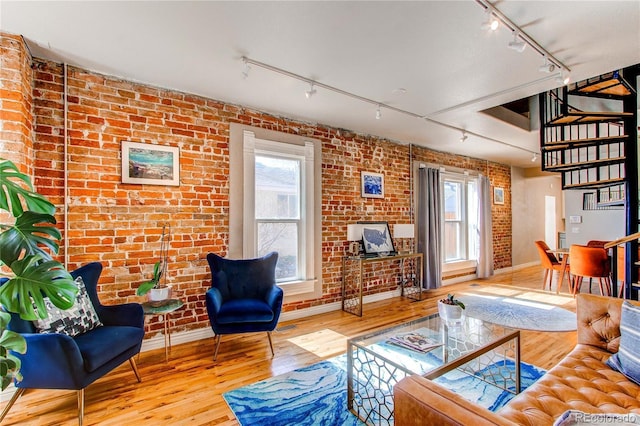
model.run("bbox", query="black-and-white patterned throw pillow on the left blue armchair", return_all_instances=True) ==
[33,277,102,337]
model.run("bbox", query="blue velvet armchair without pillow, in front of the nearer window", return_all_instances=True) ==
[206,252,283,361]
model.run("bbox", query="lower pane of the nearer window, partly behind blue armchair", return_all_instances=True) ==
[257,222,298,281]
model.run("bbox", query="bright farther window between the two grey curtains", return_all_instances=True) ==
[441,173,480,263]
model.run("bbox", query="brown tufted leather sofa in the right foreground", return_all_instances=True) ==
[394,294,640,426]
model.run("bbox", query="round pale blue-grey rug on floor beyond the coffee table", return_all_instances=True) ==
[456,293,577,331]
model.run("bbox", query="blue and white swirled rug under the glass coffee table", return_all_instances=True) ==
[223,355,545,426]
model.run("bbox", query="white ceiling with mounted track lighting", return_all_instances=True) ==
[0,0,640,167]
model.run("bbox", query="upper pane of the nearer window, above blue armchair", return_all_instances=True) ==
[255,155,300,219]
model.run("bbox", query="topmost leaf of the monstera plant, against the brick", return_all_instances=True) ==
[0,159,56,217]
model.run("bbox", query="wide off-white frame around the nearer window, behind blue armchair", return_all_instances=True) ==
[229,123,322,302]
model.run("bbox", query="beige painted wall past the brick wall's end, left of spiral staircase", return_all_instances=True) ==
[511,167,565,267]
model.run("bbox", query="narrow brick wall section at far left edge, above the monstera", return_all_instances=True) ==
[0,33,33,175]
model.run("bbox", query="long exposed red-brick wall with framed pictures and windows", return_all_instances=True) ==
[3,33,511,338]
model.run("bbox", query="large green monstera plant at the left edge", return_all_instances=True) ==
[0,158,78,389]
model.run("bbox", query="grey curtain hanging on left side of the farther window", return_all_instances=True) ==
[416,167,442,289]
